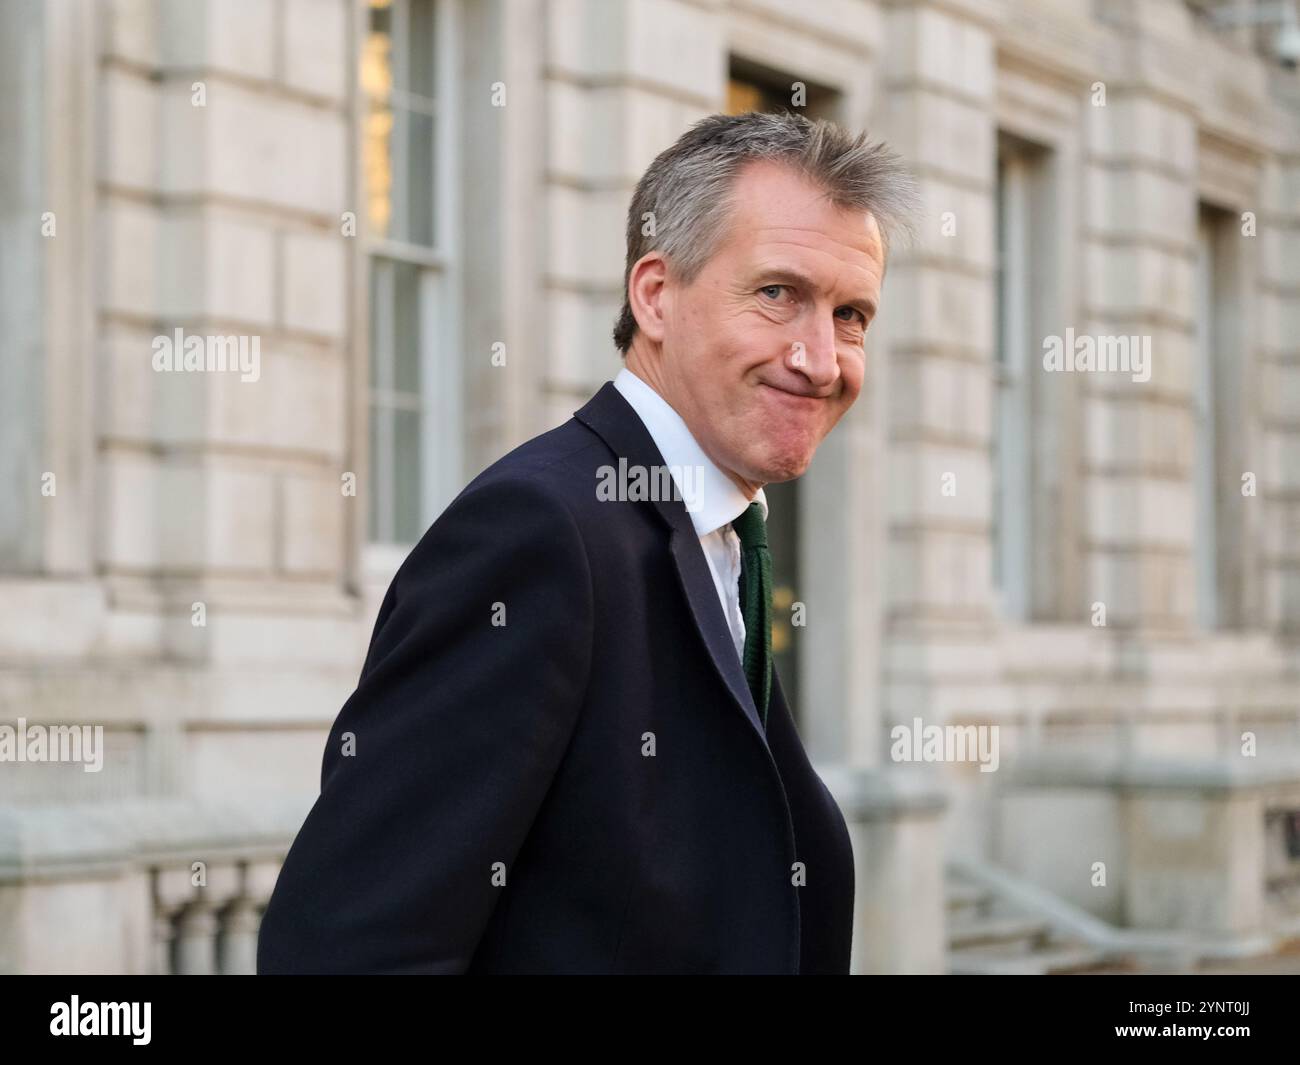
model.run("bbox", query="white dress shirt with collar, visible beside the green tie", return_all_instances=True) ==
[614,367,767,661]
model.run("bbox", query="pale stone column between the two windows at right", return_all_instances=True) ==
[1076,0,1197,633]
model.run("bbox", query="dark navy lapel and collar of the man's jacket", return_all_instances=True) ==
[573,381,767,745]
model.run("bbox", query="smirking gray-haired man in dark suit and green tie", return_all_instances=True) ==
[257,113,913,973]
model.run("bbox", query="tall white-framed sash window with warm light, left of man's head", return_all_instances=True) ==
[360,0,460,545]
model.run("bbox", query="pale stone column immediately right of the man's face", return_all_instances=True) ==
[881,3,996,636]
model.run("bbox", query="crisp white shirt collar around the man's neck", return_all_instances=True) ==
[614,367,767,536]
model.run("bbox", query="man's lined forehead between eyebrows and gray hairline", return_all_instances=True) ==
[727,160,884,272]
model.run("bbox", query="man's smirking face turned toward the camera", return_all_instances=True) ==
[647,161,884,485]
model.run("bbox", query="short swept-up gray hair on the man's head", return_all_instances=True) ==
[614,111,918,355]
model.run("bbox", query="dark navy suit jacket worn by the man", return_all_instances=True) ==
[257,384,854,973]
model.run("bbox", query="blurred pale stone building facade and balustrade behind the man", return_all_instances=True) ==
[0,0,1300,973]
